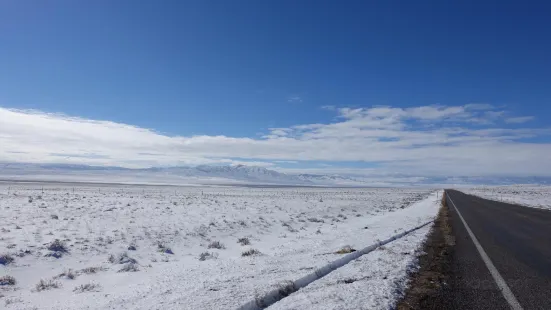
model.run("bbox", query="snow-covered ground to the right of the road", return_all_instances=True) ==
[463,185,551,210]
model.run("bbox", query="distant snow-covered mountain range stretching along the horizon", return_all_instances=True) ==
[0,163,551,186]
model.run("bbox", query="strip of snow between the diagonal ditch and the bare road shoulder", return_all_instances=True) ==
[268,194,441,310]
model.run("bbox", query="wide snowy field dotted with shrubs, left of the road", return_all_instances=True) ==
[0,184,441,309]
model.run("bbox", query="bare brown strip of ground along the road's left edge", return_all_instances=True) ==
[396,194,455,310]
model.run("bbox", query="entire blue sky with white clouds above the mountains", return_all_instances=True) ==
[0,0,551,176]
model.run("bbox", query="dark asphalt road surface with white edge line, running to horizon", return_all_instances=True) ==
[445,190,551,309]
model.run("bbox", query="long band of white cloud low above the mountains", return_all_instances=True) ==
[0,105,551,176]
